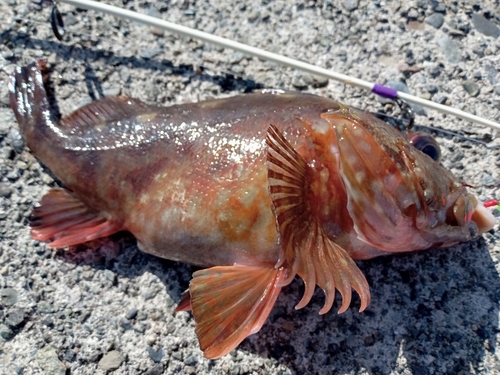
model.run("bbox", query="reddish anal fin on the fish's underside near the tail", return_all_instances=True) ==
[30,189,122,247]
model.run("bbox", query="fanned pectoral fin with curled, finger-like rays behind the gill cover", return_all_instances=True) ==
[267,125,370,314]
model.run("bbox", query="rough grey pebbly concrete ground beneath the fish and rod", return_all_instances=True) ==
[0,0,500,375]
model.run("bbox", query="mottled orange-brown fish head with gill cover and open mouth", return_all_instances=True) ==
[322,106,495,252]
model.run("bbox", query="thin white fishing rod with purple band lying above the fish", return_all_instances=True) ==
[47,0,500,130]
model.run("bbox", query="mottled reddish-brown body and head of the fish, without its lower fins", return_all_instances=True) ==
[12,63,488,266]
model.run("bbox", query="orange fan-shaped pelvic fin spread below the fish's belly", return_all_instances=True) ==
[188,265,284,359]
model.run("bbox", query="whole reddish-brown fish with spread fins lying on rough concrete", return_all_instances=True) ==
[9,60,495,359]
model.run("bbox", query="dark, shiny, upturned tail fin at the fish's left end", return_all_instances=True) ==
[9,60,58,151]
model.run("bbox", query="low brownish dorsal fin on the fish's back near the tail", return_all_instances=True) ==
[59,96,149,131]
